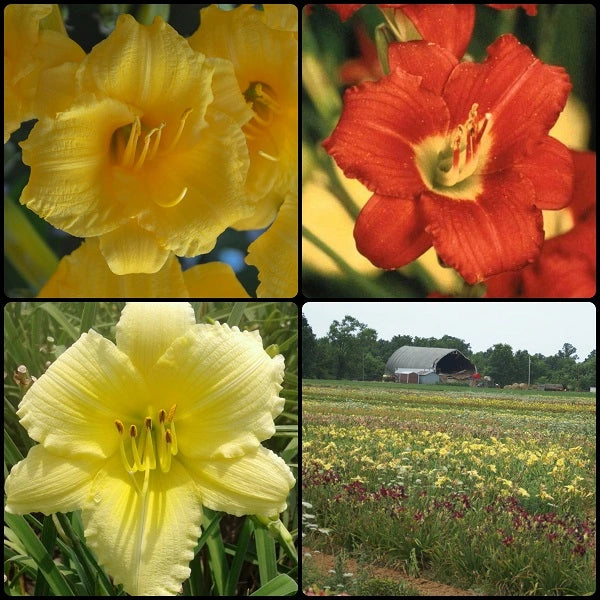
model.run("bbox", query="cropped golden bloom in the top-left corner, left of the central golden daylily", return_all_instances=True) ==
[4,4,85,143]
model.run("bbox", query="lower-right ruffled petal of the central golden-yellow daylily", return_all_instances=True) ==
[139,114,252,256]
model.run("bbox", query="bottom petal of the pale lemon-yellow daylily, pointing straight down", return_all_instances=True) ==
[82,458,202,596]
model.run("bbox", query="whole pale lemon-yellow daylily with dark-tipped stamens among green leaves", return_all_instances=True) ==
[5,302,295,596]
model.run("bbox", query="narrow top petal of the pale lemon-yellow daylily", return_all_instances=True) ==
[117,302,196,380]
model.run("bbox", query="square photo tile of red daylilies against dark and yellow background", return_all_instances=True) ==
[303,4,596,298]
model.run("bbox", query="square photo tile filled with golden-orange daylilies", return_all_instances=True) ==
[4,4,298,298]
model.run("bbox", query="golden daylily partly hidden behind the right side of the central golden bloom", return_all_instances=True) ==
[188,4,298,229]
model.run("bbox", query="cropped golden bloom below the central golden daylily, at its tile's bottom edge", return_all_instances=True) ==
[38,238,250,298]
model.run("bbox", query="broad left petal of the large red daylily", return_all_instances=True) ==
[323,69,448,198]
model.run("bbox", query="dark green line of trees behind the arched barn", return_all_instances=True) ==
[302,315,596,390]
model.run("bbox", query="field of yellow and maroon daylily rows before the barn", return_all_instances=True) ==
[302,382,596,595]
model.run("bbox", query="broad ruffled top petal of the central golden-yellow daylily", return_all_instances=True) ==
[78,14,213,134]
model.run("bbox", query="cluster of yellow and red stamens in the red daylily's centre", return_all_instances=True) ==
[435,102,492,187]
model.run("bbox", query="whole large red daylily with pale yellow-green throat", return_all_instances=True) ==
[323,35,572,284]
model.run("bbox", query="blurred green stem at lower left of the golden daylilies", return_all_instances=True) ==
[4,196,58,290]
